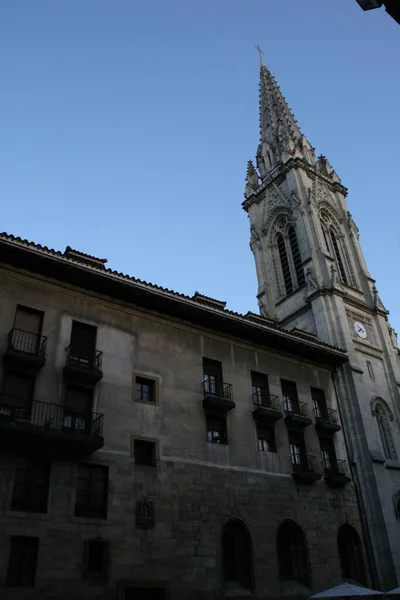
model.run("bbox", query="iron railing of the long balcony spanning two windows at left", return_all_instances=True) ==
[0,394,103,437]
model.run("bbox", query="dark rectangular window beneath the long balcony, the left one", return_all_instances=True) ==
[11,456,50,513]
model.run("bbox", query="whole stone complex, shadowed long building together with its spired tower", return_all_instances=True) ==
[0,57,398,600]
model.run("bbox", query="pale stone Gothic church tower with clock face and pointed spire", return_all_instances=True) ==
[243,62,400,589]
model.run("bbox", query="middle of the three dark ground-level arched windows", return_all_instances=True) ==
[276,521,311,587]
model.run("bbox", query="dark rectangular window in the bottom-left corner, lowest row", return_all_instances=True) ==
[6,535,39,587]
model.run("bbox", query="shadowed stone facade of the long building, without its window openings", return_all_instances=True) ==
[0,246,369,600]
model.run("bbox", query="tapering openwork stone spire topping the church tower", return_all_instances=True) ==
[257,61,315,179]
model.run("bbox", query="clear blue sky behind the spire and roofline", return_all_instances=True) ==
[0,0,400,333]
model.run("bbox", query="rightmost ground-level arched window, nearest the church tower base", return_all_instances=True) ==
[337,524,367,585]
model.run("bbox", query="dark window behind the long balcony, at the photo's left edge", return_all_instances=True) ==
[0,372,35,420]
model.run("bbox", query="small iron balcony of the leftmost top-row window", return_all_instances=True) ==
[3,327,47,374]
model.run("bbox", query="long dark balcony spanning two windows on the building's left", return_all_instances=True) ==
[0,394,104,454]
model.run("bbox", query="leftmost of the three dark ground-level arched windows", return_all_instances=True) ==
[222,519,253,591]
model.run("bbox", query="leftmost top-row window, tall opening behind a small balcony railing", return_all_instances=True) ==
[10,306,44,354]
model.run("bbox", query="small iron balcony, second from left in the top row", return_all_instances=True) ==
[63,346,103,386]
